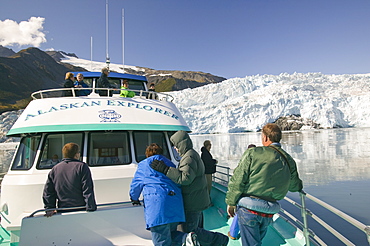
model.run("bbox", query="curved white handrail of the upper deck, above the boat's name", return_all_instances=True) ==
[31,87,174,102]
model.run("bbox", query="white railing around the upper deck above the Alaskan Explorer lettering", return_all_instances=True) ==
[31,87,174,102]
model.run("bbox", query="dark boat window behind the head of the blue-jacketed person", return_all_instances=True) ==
[134,132,171,162]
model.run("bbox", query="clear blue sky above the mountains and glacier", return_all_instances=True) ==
[0,0,370,78]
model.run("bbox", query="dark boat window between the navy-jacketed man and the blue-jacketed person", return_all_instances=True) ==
[87,131,131,166]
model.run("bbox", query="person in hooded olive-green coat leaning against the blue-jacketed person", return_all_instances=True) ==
[150,131,229,246]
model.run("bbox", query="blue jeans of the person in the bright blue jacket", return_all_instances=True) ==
[150,222,187,246]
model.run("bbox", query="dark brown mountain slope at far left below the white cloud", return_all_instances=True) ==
[0,48,85,112]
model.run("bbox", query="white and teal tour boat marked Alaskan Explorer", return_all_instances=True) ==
[0,72,369,246]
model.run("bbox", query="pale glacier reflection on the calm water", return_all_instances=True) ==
[191,128,370,187]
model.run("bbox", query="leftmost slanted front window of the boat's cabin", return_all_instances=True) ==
[11,135,41,170]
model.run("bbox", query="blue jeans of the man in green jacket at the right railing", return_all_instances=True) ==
[236,207,272,246]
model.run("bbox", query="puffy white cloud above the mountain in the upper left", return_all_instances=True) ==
[0,17,46,47]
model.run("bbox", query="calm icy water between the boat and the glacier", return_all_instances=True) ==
[191,128,370,245]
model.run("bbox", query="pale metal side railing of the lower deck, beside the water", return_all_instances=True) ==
[213,165,370,246]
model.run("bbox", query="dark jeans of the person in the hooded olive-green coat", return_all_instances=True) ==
[180,211,229,246]
